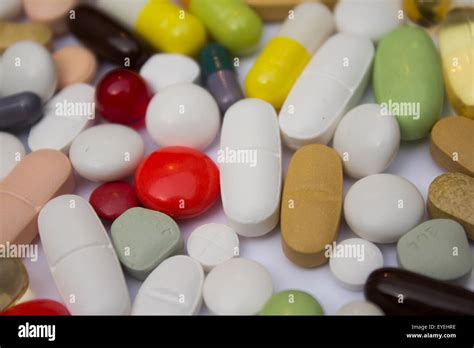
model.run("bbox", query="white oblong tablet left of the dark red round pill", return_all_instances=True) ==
[28,83,95,154]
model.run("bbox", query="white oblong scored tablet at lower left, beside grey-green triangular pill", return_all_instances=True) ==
[38,195,131,315]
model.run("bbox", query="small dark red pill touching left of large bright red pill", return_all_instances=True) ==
[89,181,140,221]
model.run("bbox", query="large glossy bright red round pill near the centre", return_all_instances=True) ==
[135,146,220,219]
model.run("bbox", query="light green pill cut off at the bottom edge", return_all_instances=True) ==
[260,290,324,315]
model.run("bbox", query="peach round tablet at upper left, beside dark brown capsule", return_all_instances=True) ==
[53,46,97,89]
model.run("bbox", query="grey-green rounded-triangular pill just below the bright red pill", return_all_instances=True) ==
[111,208,184,280]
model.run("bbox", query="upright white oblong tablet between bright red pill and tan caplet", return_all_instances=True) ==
[217,99,282,237]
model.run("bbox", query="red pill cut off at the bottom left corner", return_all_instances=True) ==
[0,300,70,316]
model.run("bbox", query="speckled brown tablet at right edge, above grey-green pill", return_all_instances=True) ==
[428,173,474,240]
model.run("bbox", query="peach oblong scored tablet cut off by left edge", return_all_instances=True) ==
[0,150,74,244]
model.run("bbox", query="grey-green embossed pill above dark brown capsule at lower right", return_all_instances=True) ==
[397,219,472,281]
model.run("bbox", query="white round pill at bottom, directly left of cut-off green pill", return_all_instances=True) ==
[203,258,273,315]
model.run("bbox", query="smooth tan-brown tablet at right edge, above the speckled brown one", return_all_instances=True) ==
[430,116,474,177]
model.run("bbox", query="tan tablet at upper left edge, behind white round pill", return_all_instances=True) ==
[0,21,53,53]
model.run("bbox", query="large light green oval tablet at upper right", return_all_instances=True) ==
[373,26,444,140]
